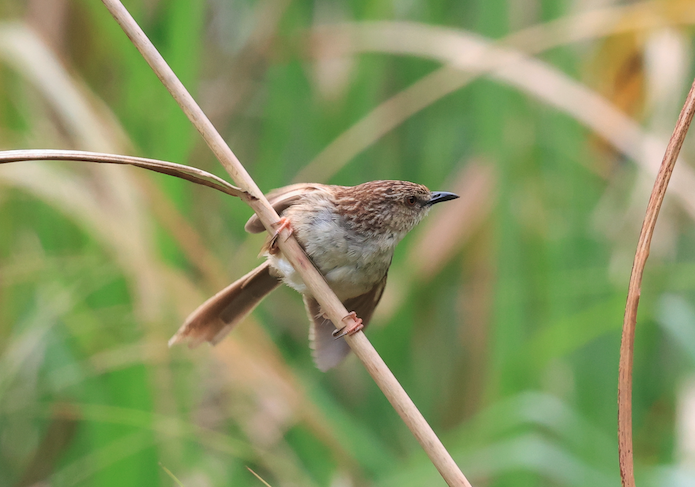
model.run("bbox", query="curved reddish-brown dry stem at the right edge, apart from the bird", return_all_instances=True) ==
[618,78,695,487]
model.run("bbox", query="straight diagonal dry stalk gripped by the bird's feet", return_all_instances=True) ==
[102,0,470,487]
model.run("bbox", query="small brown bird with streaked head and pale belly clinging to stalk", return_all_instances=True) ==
[169,181,458,371]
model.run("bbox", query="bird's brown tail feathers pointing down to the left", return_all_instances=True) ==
[169,262,280,348]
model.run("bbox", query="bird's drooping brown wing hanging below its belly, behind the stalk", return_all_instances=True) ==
[304,276,386,372]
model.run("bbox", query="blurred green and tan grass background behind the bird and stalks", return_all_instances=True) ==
[0,0,695,487]
